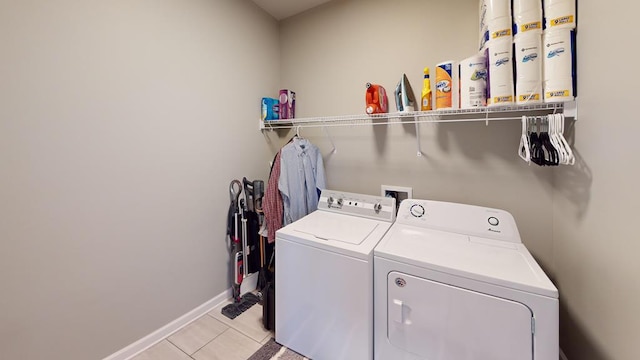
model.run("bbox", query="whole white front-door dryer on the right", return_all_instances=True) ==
[374,200,559,360]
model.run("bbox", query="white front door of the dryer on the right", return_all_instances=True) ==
[387,272,533,360]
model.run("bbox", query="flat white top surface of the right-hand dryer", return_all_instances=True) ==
[374,223,558,298]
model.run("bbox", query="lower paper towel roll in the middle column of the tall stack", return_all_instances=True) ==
[514,33,542,104]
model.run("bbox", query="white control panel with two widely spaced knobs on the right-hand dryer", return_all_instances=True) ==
[396,199,522,243]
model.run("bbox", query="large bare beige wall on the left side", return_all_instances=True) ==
[0,0,279,360]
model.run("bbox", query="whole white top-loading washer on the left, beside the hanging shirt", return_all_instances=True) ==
[275,190,396,360]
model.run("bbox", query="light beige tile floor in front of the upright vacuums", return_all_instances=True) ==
[132,302,274,360]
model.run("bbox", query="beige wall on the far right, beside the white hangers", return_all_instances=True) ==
[554,0,640,360]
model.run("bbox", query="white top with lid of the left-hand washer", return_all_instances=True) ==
[276,211,391,258]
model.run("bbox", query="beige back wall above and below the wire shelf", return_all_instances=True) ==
[278,0,553,269]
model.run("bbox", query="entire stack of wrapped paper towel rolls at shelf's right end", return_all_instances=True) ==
[476,0,576,106]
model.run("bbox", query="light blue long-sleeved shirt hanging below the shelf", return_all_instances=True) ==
[278,137,326,225]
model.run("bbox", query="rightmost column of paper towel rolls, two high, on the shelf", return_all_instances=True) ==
[543,0,576,102]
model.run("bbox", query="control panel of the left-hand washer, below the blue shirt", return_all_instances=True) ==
[318,190,396,222]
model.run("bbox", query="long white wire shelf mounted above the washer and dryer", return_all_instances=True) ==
[260,103,565,130]
